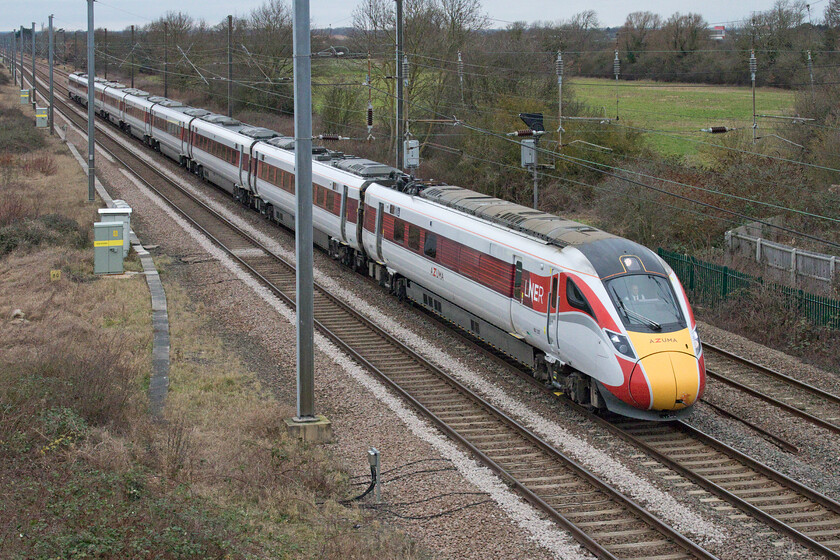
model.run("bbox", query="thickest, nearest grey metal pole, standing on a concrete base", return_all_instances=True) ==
[294,0,316,422]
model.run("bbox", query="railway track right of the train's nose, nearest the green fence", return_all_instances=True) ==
[703,343,840,434]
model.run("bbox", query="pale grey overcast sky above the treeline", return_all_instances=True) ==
[0,0,796,30]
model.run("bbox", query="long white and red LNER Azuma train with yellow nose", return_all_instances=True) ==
[69,73,705,420]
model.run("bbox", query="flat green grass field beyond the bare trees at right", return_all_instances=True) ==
[569,78,795,156]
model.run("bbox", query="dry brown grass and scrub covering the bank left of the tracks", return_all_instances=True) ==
[0,66,424,559]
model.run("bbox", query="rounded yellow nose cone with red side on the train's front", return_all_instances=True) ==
[630,352,699,410]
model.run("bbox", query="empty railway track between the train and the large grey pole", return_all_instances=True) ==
[18,61,714,560]
